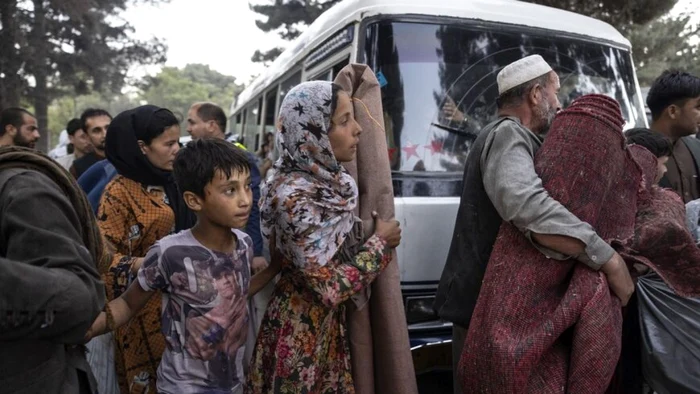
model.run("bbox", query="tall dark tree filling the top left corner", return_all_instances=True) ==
[0,0,167,149]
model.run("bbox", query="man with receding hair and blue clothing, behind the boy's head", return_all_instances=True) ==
[187,102,267,272]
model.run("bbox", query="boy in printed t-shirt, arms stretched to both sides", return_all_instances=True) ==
[88,139,280,394]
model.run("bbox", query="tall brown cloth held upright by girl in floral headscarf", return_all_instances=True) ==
[335,64,418,394]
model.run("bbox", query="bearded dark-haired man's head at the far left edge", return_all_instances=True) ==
[0,107,41,149]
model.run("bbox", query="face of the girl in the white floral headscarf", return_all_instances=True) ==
[328,91,362,163]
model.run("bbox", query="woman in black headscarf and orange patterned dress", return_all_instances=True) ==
[97,105,194,394]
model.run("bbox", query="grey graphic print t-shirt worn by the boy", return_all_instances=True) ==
[138,230,253,394]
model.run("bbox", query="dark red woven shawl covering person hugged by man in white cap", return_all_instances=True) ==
[459,95,642,394]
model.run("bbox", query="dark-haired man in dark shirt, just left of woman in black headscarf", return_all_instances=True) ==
[70,108,112,179]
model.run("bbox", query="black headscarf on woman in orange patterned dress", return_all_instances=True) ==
[105,105,196,231]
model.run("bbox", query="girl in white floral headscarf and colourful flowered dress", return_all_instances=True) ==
[247,82,401,393]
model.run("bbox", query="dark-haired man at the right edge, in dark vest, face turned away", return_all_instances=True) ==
[647,71,700,203]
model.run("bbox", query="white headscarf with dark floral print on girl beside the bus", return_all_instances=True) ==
[260,82,357,266]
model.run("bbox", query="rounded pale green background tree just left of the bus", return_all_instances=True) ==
[139,64,243,134]
